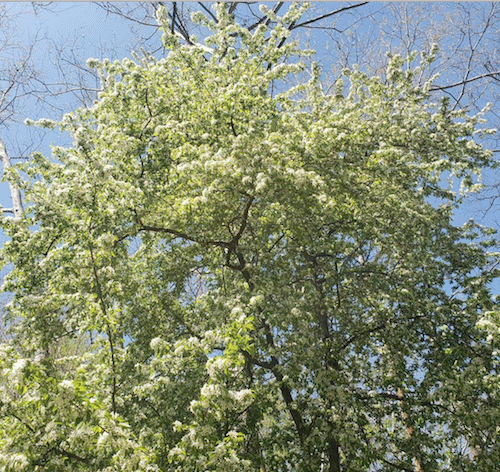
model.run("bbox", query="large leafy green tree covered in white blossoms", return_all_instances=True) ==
[0,5,500,472]
